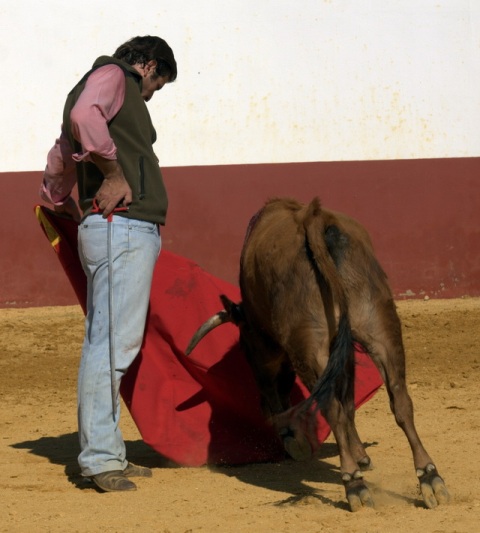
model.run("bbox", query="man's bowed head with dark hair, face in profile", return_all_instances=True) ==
[113,35,177,102]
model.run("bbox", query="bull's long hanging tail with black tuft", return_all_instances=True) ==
[303,198,355,409]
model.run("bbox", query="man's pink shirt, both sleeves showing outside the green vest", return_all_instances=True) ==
[40,65,125,205]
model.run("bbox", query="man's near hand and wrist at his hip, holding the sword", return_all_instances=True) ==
[90,153,132,218]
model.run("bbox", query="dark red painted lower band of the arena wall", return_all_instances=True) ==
[0,158,480,307]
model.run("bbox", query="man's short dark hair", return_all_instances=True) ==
[113,35,177,82]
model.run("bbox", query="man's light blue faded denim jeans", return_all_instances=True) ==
[78,215,161,476]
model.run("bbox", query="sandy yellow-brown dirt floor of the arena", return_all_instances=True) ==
[0,298,480,533]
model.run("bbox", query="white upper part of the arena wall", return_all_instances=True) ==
[0,0,480,171]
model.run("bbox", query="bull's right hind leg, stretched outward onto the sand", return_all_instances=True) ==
[369,302,449,509]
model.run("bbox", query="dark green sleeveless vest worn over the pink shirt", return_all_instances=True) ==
[63,56,168,224]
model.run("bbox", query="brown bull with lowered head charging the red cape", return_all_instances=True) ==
[187,198,449,511]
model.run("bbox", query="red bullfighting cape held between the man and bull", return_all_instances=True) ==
[35,206,382,466]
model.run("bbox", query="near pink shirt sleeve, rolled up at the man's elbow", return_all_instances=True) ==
[70,65,125,161]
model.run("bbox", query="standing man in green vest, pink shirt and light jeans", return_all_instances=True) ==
[40,36,177,491]
